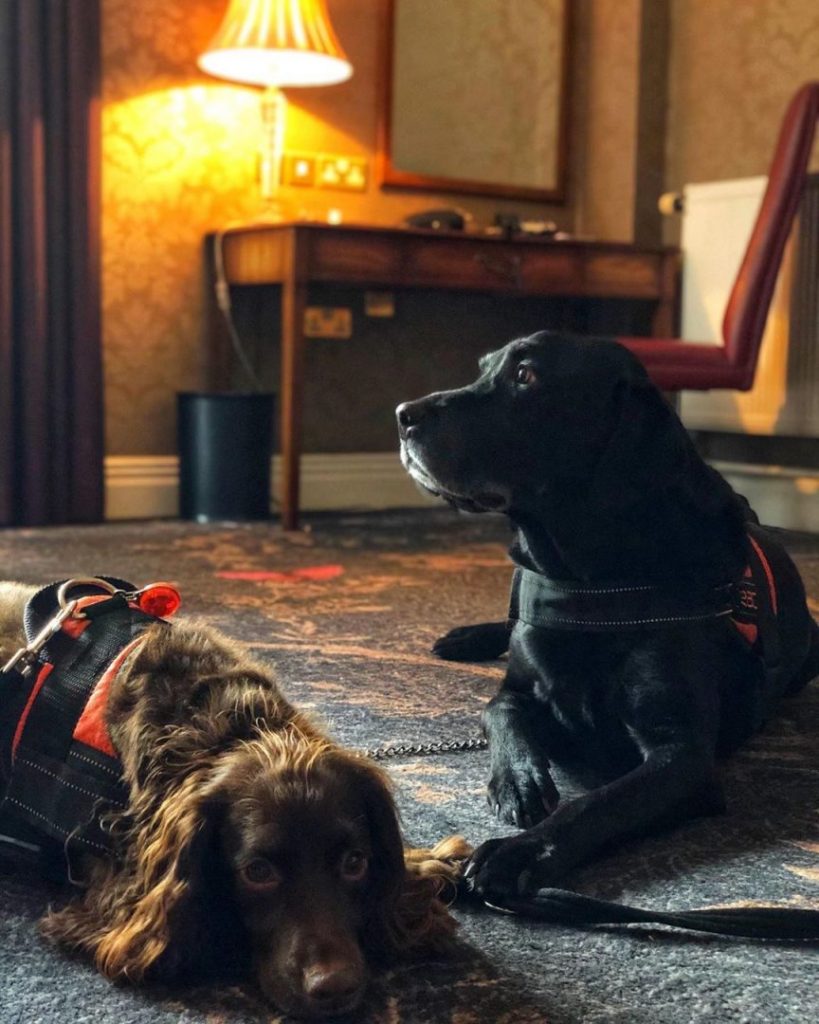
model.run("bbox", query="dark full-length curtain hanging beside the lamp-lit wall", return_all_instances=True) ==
[0,0,102,525]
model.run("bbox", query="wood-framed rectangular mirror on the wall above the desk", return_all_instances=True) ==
[380,0,570,202]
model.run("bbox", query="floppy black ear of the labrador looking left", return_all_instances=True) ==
[590,378,692,512]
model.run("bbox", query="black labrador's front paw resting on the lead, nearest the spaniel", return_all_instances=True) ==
[464,829,565,902]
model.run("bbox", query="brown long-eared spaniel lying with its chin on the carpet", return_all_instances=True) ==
[0,585,468,1017]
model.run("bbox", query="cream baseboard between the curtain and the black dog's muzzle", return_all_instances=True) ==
[105,452,436,519]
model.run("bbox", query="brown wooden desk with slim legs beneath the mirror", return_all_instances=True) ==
[210,222,679,529]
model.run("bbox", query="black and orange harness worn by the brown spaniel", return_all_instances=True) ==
[0,577,179,878]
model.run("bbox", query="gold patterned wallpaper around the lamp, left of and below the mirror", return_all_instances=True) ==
[102,0,570,455]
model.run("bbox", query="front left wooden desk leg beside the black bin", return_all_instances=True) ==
[281,273,307,529]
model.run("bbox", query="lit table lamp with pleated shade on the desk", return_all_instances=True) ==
[198,0,352,215]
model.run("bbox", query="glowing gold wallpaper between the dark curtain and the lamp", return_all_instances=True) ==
[102,0,258,455]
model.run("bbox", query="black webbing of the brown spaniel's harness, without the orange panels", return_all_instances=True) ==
[0,578,161,877]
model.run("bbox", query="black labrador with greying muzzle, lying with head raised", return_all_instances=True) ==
[396,332,819,895]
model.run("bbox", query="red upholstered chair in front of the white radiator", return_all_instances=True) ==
[617,82,819,391]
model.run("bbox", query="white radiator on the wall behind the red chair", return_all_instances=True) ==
[681,175,819,436]
